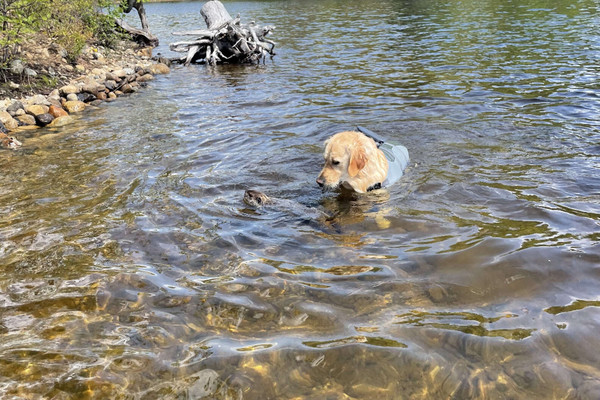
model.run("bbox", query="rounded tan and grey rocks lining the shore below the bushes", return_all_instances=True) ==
[0,44,170,149]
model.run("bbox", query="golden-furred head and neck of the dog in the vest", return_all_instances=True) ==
[317,131,388,193]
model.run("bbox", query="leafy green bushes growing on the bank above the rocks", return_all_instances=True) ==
[0,0,123,69]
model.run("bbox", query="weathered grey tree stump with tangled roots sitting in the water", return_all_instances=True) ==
[170,0,275,65]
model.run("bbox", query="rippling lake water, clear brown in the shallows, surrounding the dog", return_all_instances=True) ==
[0,0,600,399]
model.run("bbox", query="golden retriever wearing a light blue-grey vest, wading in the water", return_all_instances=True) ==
[317,127,409,193]
